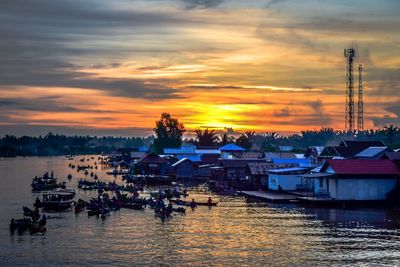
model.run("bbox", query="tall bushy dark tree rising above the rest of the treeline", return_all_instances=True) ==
[153,113,185,154]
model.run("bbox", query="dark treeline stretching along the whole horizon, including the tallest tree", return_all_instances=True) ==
[0,113,400,157]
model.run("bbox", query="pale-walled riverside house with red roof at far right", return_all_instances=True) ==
[302,159,400,201]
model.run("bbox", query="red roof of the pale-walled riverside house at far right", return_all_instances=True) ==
[323,159,400,175]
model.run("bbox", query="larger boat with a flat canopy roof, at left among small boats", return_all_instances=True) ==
[35,191,75,211]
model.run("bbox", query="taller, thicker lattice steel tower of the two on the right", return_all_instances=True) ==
[344,48,355,131]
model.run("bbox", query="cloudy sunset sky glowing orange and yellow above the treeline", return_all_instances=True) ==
[0,0,400,135]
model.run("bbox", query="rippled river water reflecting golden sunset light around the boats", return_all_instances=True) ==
[0,157,400,266]
